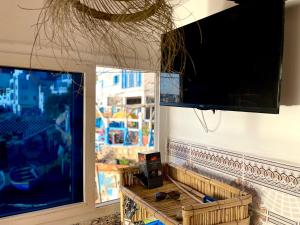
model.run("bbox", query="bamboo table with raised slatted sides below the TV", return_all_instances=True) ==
[119,164,252,225]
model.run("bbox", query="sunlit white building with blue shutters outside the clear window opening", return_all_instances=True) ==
[96,67,155,118]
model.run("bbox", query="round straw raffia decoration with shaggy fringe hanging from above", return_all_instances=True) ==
[35,0,183,71]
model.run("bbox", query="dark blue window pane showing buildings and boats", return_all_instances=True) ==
[0,66,83,218]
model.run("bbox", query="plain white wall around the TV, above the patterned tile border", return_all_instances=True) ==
[160,0,300,165]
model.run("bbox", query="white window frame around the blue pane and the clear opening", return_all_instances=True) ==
[0,59,164,225]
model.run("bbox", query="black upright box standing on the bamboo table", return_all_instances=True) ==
[137,152,163,188]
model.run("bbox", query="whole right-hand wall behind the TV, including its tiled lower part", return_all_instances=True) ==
[160,0,300,225]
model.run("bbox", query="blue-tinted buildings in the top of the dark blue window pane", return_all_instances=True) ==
[0,70,72,115]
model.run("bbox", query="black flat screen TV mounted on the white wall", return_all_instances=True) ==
[160,0,284,114]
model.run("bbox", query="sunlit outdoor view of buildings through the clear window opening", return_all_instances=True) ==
[95,67,155,203]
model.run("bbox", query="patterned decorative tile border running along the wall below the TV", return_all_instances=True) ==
[168,139,300,197]
